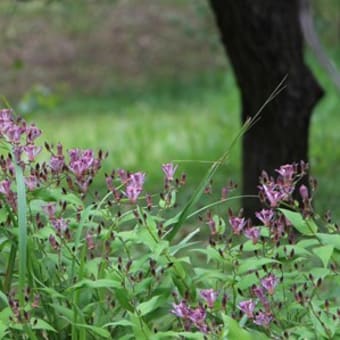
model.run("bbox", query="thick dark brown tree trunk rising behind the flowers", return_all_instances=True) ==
[210,0,323,216]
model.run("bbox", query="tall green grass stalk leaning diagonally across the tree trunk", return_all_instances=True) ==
[165,76,287,242]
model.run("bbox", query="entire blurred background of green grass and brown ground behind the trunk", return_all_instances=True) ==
[0,0,340,220]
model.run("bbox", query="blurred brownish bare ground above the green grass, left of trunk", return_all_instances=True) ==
[0,0,226,98]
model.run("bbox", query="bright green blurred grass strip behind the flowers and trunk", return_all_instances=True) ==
[21,66,340,220]
